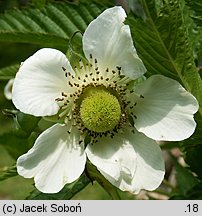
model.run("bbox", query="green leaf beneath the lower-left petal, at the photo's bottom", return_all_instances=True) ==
[26,174,90,200]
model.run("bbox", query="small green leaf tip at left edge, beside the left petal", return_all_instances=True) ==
[0,64,20,80]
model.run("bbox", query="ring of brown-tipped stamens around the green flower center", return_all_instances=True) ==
[55,54,138,144]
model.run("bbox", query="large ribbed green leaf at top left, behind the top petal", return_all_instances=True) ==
[0,2,105,47]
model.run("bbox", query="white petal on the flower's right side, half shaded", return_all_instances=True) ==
[133,75,198,141]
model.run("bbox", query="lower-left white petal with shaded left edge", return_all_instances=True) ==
[17,124,86,193]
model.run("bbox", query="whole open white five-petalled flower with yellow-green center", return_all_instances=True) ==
[13,6,198,194]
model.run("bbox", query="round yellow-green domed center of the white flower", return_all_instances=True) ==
[80,87,121,133]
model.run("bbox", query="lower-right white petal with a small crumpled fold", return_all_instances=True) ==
[86,130,165,194]
